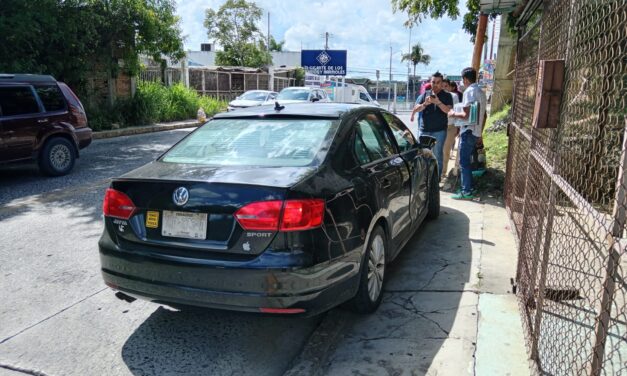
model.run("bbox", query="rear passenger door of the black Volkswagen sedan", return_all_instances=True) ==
[354,112,411,252]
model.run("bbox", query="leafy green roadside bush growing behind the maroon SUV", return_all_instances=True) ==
[86,82,227,130]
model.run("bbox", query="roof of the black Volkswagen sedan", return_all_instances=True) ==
[213,101,381,119]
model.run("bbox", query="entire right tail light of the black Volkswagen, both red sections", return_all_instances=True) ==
[235,199,324,231]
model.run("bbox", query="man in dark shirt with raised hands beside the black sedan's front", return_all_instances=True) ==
[410,72,453,180]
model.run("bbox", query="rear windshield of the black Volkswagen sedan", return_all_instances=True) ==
[161,119,336,167]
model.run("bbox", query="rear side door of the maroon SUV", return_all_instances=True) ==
[0,85,48,162]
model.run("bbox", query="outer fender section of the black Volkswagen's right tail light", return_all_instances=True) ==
[281,199,324,231]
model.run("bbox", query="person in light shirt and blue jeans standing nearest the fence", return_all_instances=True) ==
[448,68,487,200]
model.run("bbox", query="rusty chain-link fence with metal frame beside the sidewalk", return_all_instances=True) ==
[505,0,627,376]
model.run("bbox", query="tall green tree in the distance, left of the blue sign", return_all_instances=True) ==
[204,0,272,67]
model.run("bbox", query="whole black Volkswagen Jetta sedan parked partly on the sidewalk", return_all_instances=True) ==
[99,103,440,315]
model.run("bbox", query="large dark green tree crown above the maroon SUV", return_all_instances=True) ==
[0,0,184,88]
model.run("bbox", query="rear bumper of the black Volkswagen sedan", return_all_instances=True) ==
[99,235,360,316]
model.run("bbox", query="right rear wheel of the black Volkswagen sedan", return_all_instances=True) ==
[349,226,387,313]
